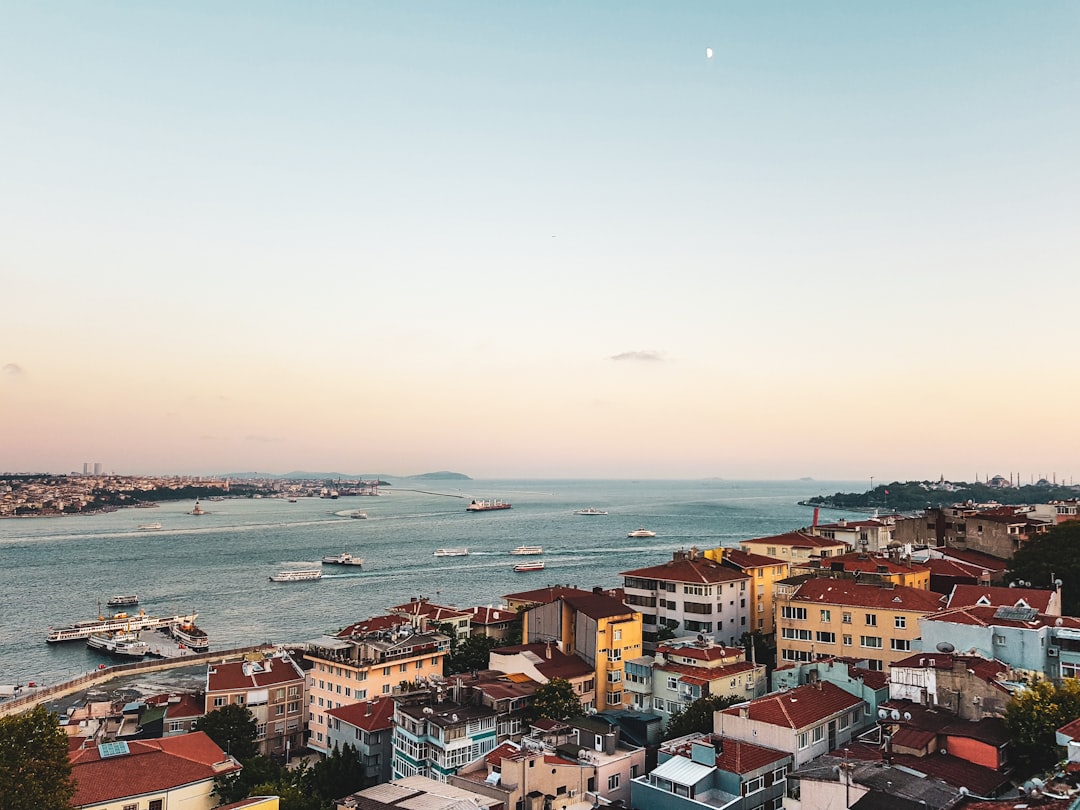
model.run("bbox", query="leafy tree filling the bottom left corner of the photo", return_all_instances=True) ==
[0,706,75,810]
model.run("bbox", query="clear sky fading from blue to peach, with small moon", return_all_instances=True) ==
[0,0,1080,481]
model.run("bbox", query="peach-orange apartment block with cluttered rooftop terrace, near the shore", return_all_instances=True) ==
[303,617,450,754]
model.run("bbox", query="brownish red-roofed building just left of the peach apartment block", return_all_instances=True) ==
[205,652,307,757]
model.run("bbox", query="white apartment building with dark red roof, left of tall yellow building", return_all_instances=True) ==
[619,549,752,651]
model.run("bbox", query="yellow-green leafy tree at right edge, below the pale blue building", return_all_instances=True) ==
[1005,678,1080,775]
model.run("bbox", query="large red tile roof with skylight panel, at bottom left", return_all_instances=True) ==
[71,731,240,807]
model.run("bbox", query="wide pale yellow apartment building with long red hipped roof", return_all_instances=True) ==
[777,577,944,670]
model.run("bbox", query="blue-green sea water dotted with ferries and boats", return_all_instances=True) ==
[0,481,865,684]
